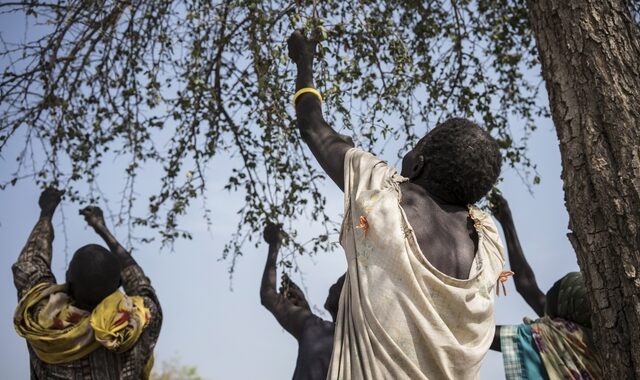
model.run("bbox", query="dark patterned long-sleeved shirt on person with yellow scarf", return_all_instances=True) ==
[12,217,162,380]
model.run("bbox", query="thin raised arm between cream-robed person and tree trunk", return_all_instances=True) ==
[492,194,547,317]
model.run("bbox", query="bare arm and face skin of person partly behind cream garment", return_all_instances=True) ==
[260,224,340,340]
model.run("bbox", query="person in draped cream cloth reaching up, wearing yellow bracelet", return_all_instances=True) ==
[288,32,504,380]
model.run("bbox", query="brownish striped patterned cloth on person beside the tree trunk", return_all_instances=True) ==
[531,317,602,380]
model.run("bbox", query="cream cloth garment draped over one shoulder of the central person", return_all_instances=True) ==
[327,149,504,380]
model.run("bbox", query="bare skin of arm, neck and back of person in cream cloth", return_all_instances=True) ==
[288,31,478,279]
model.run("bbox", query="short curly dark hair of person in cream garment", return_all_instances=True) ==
[416,118,502,205]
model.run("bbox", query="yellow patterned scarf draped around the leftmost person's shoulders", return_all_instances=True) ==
[14,283,152,374]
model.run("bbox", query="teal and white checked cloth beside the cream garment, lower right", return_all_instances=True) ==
[500,324,549,380]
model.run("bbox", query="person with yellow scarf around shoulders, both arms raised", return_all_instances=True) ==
[12,188,162,380]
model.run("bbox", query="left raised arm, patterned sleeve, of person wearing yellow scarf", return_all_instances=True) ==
[12,187,64,298]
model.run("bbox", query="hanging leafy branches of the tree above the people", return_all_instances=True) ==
[0,0,546,263]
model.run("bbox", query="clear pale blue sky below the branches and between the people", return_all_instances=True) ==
[0,7,577,379]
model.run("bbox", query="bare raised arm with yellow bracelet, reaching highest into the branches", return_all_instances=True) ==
[288,31,352,190]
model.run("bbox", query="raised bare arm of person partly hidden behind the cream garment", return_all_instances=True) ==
[260,224,313,339]
